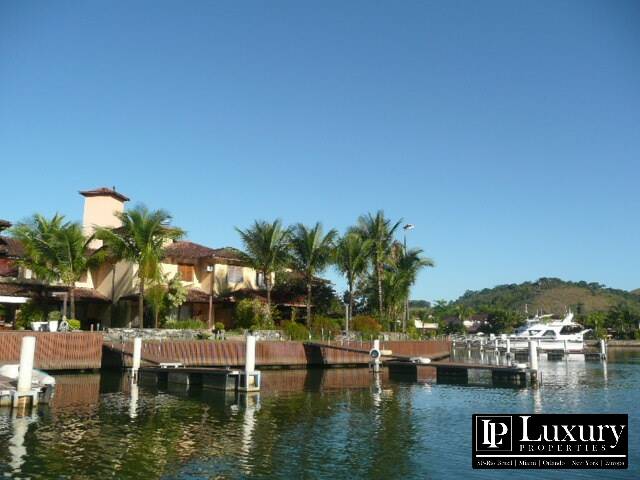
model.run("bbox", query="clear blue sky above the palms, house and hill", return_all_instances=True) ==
[0,0,640,299]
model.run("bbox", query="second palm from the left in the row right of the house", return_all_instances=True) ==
[291,222,338,326]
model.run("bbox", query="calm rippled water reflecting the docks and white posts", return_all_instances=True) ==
[0,350,640,480]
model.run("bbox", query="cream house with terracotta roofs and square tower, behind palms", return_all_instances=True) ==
[0,187,301,327]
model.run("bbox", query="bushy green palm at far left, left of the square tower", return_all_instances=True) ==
[13,214,103,318]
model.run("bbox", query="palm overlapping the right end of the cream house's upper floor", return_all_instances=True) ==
[236,219,290,318]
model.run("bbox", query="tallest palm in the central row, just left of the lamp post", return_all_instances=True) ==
[355,210,402,323]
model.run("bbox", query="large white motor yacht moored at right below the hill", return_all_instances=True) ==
[500,312,591,351]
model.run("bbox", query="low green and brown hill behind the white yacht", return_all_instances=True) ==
[455,278,640,314]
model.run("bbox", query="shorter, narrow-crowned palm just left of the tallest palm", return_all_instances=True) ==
[334,232,372,331]
